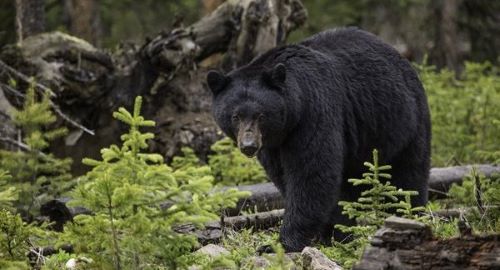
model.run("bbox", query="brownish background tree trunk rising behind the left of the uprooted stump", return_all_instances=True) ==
[64,0,102,47]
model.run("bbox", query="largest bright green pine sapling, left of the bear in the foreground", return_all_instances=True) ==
[63,97,247,269]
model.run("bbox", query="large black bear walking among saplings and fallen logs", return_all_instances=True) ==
[207,28,431,251]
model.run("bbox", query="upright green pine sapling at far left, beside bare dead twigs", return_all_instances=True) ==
[0,84,72,220]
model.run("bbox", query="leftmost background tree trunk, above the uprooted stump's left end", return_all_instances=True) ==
[16,0,45,41]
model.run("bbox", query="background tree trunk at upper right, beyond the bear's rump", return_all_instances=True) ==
[432,0,461,72]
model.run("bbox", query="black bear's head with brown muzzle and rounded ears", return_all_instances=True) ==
[207,64,287,157]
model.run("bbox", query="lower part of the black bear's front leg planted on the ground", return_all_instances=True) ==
[280,160,340,252]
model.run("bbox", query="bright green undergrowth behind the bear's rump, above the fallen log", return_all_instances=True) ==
[416,62,500,167]
